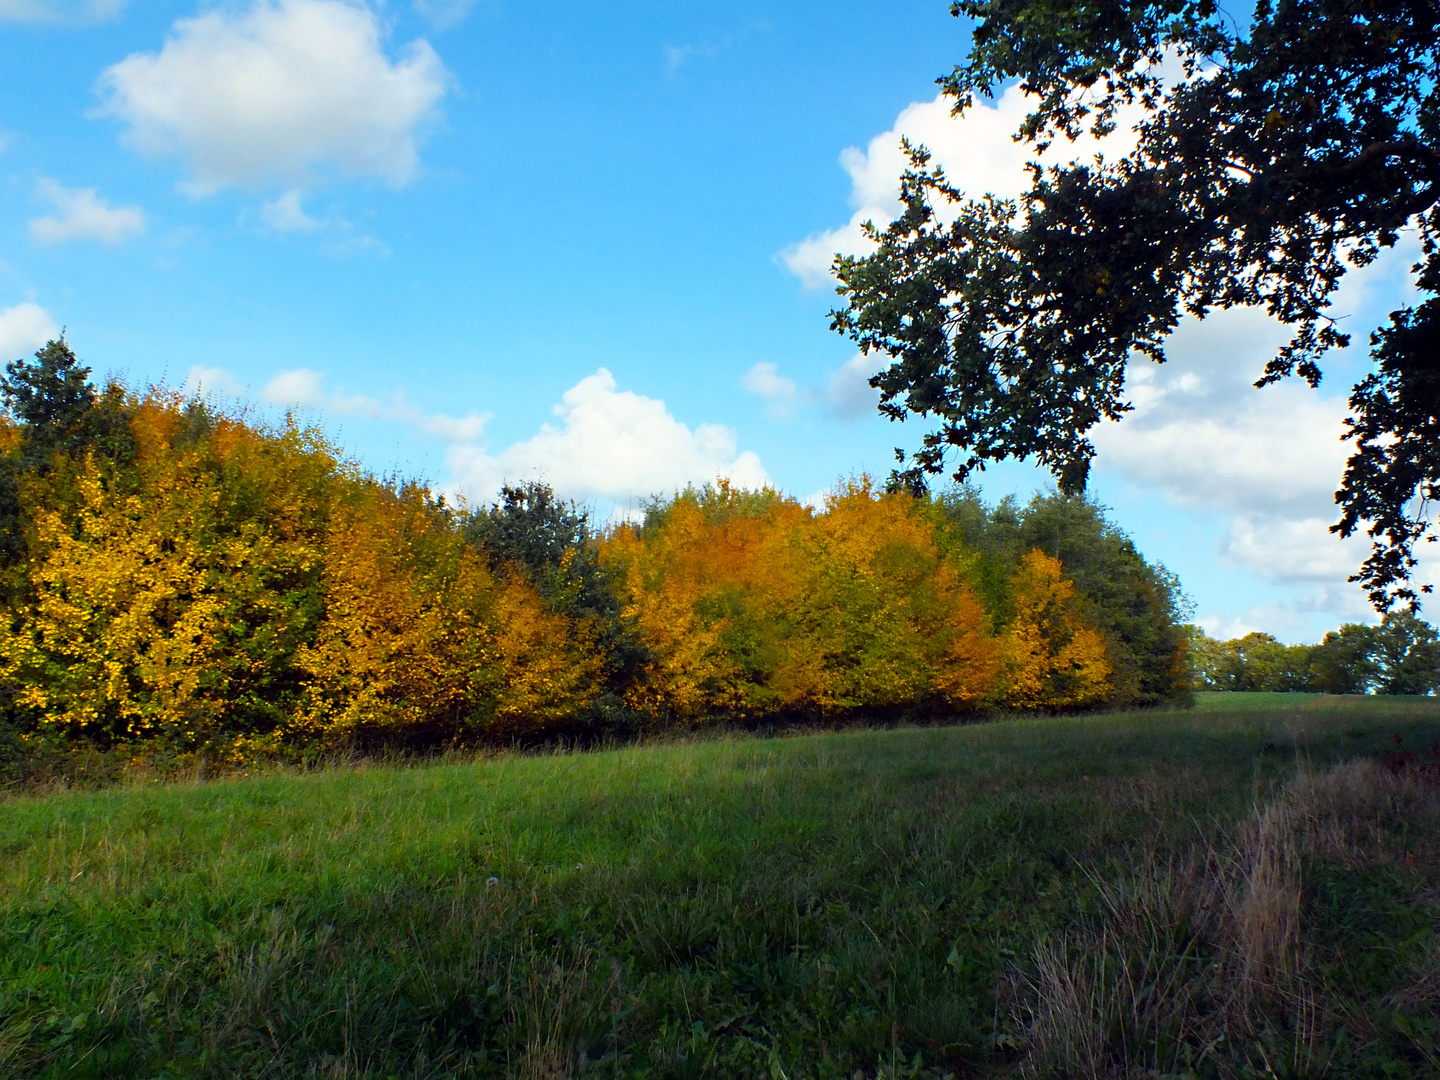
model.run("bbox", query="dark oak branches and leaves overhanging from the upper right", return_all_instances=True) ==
[832,0,1440,609]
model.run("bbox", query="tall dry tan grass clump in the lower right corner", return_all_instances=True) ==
[1002,760,1440,1080]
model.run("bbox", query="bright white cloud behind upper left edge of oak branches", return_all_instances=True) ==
[779,85,1135,288]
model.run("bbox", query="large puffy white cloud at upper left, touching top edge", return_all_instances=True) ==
[99,0,449,194]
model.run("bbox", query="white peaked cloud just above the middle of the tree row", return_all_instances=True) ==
[449,367,769,500]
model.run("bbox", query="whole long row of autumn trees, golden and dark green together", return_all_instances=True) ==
[0,341,1191,760]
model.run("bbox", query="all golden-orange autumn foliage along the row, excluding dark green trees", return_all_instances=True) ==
[0,393,1109,757]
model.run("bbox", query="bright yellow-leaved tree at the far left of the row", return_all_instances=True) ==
[0,397,333,744]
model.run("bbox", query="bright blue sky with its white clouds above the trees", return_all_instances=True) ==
[0,0,1408,639]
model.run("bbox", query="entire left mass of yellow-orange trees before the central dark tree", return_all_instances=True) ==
[0,393,598,752]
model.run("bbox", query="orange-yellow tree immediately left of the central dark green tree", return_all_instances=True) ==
[301,484,599,740]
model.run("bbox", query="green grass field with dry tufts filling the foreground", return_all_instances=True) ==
[0,696,1440,1080]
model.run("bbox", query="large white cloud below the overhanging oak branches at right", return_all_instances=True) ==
[1094,246,1440,616]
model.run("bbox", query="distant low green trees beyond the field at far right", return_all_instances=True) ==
[1191,611,1440,694]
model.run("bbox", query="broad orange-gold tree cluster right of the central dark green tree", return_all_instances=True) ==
[602,481,998,723]
